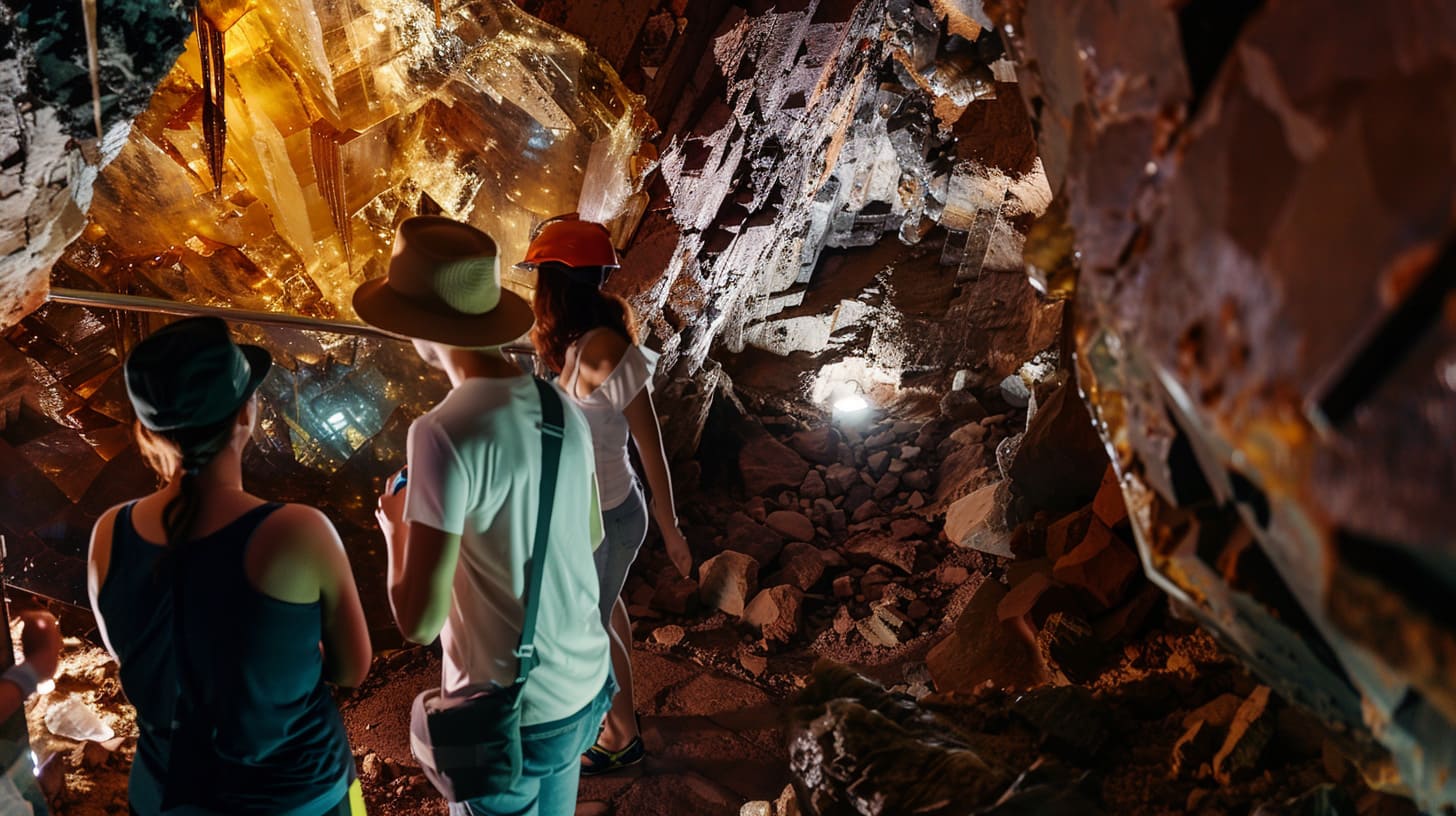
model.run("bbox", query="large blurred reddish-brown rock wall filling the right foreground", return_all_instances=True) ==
[987,0,1456,809]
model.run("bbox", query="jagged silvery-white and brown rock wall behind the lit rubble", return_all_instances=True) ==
[523,0,1061,453]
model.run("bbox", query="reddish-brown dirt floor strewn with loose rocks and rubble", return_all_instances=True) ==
[5,415,1415,816]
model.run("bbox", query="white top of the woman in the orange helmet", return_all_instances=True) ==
[565,328,657,510]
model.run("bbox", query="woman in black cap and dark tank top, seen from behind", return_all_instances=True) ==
[89,318,370,816]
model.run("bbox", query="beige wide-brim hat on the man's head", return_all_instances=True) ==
[354,216,536,348]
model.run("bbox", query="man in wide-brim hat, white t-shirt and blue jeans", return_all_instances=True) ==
[364,216,612,816]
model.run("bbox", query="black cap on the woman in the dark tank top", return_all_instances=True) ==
[124,318,272,431]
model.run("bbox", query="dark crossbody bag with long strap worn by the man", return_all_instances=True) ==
[409,379,565,801]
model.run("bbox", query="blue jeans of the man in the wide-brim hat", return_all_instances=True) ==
[450,673,617,816]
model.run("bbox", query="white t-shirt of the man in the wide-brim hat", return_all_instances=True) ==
[405,376,610,724]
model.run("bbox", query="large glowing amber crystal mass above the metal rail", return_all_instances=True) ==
[57,0,655,319]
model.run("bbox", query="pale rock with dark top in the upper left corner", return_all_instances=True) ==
[0,0,191,329]
